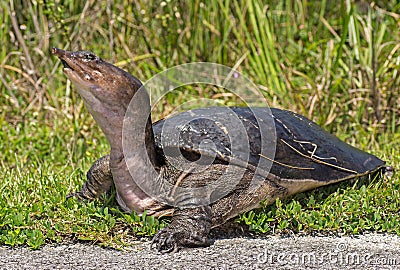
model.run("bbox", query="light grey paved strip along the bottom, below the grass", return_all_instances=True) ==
[0,234,400,270]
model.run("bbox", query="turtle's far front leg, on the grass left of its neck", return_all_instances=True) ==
[66,155,113,200]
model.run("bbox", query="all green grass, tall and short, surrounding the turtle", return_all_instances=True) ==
[0,0,400,249]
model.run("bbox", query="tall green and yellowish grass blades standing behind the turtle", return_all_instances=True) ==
[0,0,400,127]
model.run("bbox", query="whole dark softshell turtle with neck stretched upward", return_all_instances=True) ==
[52,48,385,252]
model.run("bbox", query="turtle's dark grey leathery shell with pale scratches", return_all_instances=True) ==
[153,107,385,187]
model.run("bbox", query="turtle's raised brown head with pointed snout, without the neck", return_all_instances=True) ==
[52,48,142,111]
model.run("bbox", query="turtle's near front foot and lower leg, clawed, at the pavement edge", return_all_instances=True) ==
[151,206,211,253]
